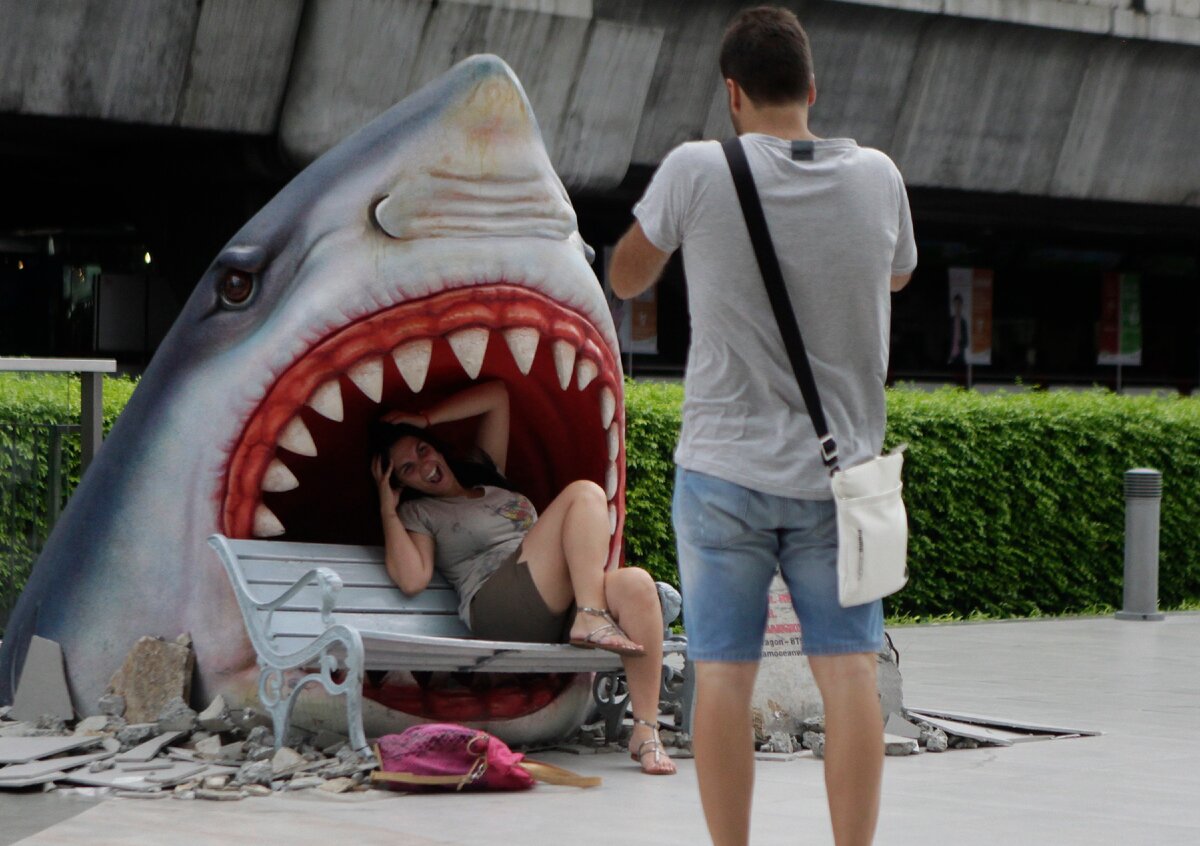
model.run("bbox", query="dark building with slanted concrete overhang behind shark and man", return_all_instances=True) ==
[0,0,1200,392]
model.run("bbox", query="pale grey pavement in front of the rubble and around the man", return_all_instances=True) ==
[0,613,1200,846]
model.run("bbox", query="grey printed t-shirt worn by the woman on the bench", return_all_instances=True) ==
[398,485,538,626]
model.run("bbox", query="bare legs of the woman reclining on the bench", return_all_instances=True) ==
[522,481,674,774]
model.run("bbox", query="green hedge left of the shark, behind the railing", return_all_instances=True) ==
[0,373,133,614]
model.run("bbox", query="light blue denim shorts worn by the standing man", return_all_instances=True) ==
[672,468,883,661]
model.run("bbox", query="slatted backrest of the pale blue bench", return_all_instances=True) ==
[215,539,470,648]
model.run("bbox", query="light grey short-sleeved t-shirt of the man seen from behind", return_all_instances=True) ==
[634,133,917,499]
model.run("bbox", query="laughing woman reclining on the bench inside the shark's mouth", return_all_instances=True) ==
[371,382,676,775]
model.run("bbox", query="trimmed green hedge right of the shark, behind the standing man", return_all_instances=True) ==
[625,383,1200,617]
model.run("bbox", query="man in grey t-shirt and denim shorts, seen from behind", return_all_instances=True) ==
[610,7,917,846]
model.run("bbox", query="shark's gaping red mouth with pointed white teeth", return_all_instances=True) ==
[220,278,624,721]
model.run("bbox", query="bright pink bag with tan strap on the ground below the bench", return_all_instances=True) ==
[371,722,600,791]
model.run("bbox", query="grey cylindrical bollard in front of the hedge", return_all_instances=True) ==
[1116,467,1165,620]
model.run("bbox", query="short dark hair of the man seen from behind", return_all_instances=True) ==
[720,6,812,106]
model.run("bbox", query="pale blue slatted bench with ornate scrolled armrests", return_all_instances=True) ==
[209,534,692,750]
